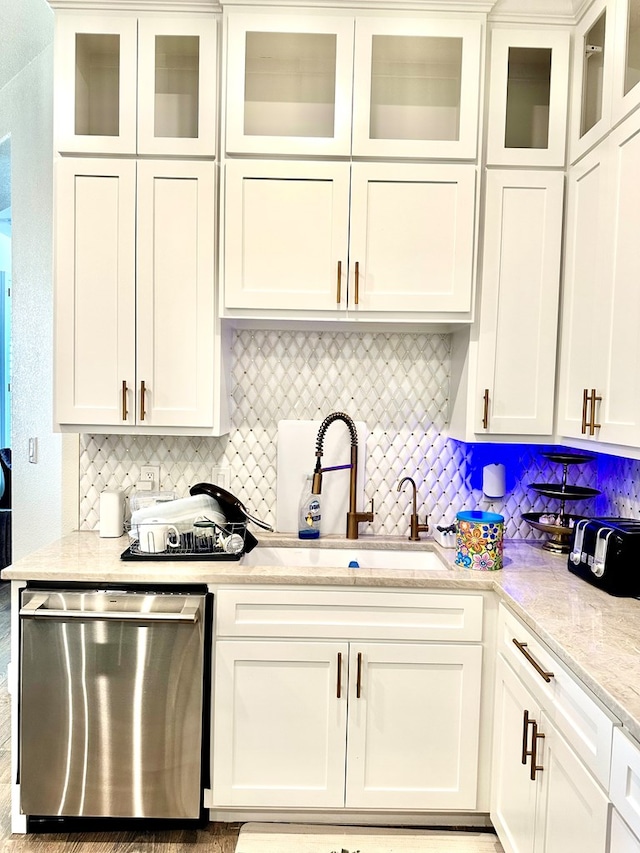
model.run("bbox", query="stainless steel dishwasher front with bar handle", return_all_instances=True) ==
[19,589,206,819]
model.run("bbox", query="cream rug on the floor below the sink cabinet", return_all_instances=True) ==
[236,823,503,853]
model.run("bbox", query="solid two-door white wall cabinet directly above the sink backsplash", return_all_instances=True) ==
[224,160,476,319]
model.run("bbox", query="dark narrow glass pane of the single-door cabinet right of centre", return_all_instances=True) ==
[504,47,551,148]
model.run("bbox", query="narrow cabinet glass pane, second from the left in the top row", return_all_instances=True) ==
[154,36,200,139]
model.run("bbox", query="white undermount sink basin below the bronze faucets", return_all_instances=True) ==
[242,546,446,572]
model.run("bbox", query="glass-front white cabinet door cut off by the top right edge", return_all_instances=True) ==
[612,0,640,123]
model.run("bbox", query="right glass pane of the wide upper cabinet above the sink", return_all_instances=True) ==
[369,35,462,140]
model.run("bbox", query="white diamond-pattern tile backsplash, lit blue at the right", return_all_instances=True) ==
[79,330,640,538]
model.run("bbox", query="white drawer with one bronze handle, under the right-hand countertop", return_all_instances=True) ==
[498,605,614,788]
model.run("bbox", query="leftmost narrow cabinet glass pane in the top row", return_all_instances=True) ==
[75,33,120,136]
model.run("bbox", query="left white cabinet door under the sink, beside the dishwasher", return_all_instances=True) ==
[212,640,348,808]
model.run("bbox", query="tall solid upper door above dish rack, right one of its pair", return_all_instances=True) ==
[136,160,216,427]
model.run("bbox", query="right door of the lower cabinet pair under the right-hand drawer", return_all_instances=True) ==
[534,712,609,853]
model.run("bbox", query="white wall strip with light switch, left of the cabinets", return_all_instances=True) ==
[0,10,77,559]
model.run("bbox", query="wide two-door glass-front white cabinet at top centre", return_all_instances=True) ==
[225,8,482,159]
